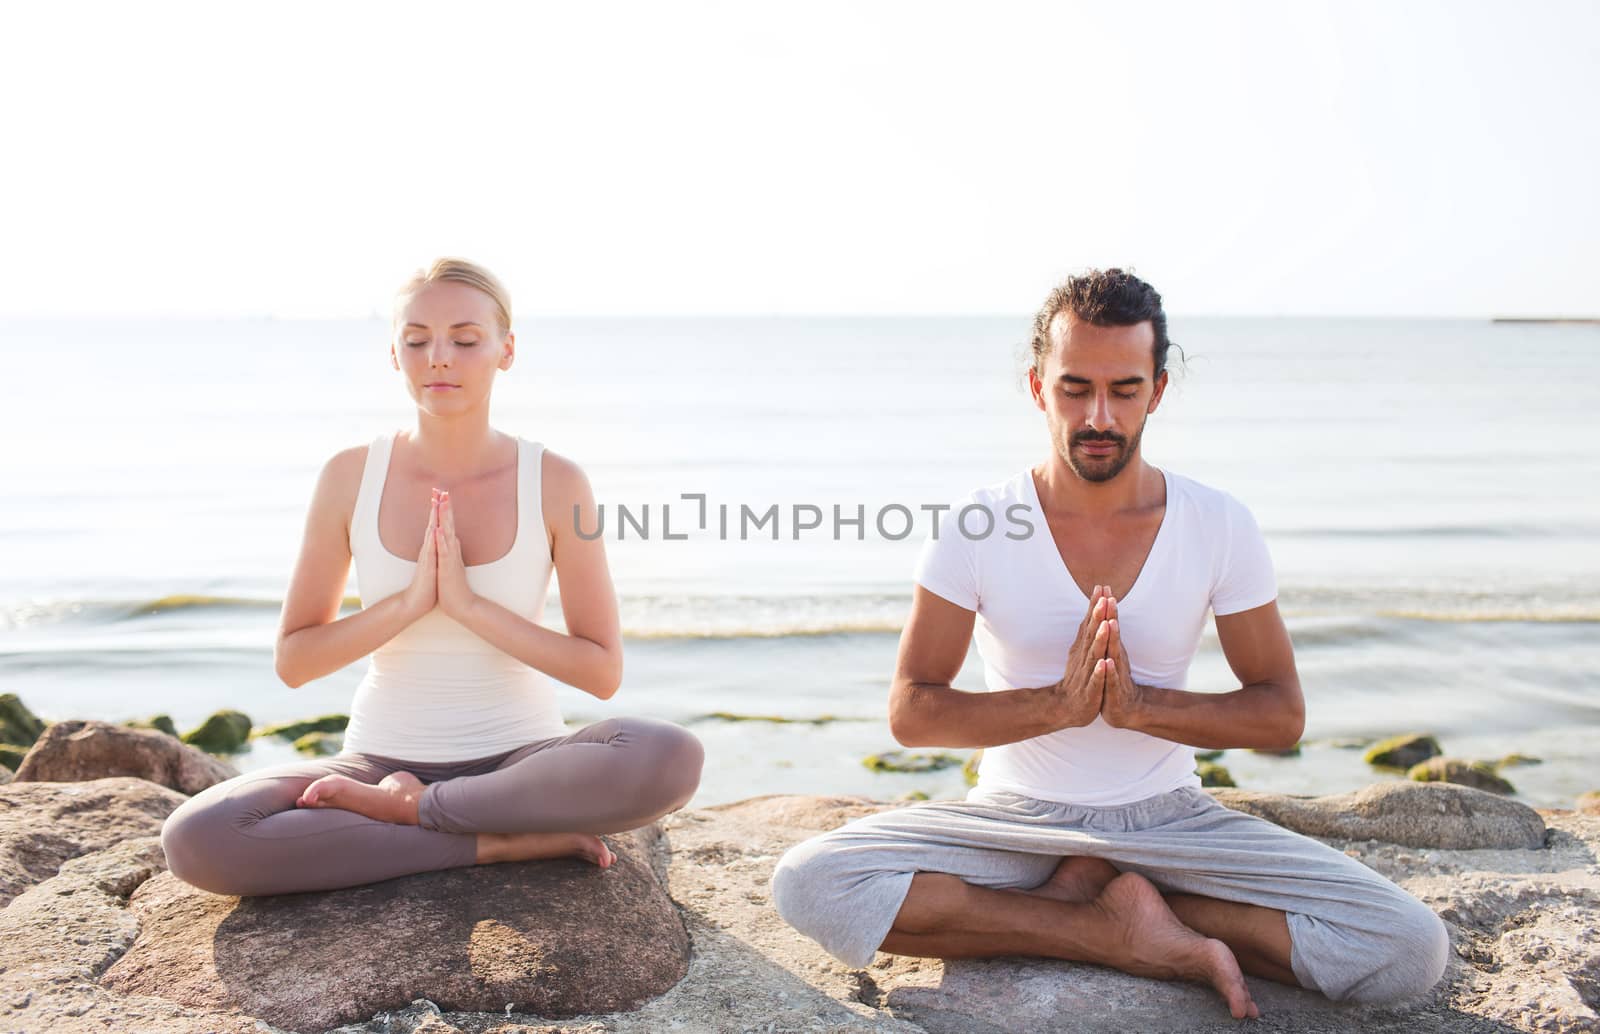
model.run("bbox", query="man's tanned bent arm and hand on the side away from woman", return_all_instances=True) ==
[1101,600,1306,751]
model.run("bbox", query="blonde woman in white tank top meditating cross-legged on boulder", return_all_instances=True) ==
[162,259,702,895]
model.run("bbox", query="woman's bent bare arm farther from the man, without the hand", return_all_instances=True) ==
[272,447,426,688]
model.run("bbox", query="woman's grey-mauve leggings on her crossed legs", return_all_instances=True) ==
[162,719,704,895]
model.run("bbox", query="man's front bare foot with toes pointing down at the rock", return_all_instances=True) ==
[1094,872,1261,1020]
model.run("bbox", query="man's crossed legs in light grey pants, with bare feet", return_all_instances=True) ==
[773,788,1448,1018]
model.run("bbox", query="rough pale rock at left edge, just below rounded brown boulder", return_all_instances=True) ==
[0,780,184,904]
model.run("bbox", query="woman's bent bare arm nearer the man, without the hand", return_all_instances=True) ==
[461,450,622,699]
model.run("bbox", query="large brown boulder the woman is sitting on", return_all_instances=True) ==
[101,828,690,1031]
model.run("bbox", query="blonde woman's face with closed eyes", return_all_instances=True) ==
[389,280,514,415]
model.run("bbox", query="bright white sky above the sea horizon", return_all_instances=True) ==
[0,0,1600,319]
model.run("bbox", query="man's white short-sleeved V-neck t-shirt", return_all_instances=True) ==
[917,471,1278,805]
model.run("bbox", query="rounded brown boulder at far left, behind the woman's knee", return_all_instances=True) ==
[16,722,238,796]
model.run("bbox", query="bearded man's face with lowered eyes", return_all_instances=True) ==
[1027,312,1166,482]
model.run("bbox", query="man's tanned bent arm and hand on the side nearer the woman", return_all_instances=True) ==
[890,586,1109,747]
